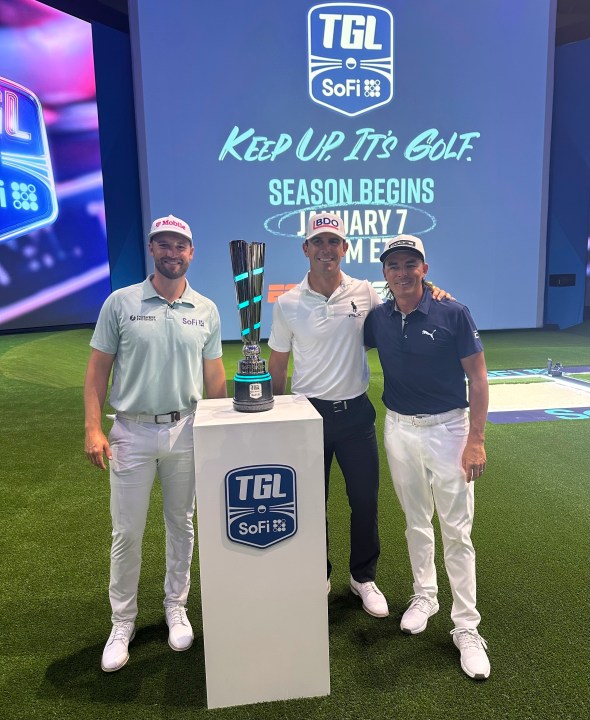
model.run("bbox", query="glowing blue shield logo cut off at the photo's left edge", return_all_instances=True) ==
[0,77,57,241]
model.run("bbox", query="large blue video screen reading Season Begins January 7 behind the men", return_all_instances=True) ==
[131,0,555,339]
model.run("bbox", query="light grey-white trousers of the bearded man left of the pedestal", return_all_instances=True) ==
[109,413,195,622]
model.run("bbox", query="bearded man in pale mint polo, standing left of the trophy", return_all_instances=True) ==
[84,215,226,672]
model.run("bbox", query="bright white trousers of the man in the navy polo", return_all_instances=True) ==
[384,410,480,628]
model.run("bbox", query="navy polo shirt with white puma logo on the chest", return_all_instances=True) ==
[364,290,483,415]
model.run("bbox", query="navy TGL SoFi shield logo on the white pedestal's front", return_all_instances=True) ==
[225,465,297,548]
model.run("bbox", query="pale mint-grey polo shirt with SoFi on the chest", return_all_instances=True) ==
[90,278,222,415]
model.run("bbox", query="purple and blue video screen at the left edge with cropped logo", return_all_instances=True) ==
[0,0,111,331]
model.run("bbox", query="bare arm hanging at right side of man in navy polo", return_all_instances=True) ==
[461,352,489,482]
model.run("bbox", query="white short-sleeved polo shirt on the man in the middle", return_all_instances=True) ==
[268,273,381,400]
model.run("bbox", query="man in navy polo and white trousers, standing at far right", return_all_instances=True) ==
[364,235,490,679]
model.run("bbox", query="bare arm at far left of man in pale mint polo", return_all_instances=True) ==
[84,349,115,470]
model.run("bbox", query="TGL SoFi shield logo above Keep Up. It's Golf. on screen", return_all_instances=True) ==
[307,3,393,117]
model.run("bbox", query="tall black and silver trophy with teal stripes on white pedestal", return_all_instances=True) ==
[229,240,274,412]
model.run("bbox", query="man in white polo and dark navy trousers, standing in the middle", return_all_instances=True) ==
[268,212,445,618]
